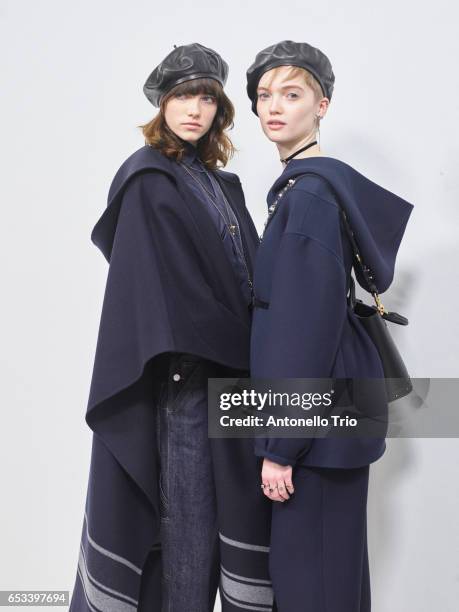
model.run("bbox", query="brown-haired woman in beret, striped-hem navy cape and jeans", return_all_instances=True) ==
[70,44,273,612]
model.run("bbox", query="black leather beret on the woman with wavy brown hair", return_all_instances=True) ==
[143,43,228,106]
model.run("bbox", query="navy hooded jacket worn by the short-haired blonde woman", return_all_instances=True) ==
[250,156,413,468]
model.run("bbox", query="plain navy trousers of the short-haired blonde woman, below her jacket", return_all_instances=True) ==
[269,465,371,612]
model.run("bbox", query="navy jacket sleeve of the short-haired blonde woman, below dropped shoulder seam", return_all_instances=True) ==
[251,232,346,465]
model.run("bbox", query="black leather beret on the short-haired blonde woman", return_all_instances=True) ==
[247,40,335,115]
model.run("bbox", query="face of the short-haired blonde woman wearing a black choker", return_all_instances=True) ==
[257,66,323,148]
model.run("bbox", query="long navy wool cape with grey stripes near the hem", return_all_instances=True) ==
[70,146,275,612]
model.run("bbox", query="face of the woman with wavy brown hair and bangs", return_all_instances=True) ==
[164,94,217,145]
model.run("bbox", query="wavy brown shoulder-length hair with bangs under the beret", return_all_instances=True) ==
[138,79,235,169]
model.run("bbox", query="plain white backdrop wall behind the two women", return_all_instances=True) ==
[0,0,459,612]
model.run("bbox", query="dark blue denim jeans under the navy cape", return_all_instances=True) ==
[157,354,220,612]
